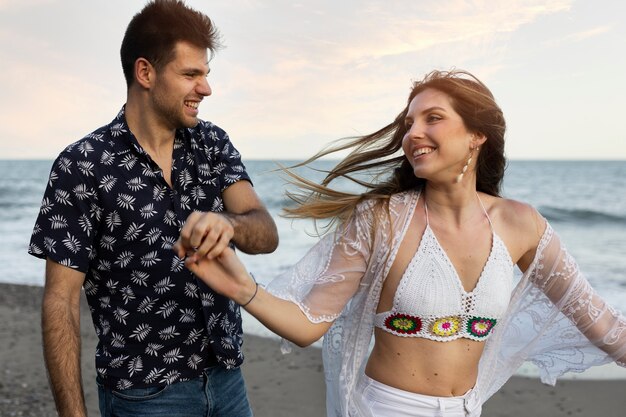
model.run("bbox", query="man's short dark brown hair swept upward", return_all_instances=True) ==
[120,0,220,87]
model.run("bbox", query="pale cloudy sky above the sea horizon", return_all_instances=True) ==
[0,0,626,160]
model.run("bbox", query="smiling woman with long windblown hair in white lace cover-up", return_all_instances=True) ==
[175,71,626,417]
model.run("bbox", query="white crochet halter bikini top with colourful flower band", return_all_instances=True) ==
[375,193,513,342]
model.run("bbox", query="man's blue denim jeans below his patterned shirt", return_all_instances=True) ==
[97,366,252,417]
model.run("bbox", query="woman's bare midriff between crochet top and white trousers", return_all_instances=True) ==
[365,328,484,397]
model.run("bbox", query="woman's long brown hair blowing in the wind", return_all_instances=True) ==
[284,70,506,227]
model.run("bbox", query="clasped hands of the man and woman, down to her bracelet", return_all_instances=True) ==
[172,211,256,304]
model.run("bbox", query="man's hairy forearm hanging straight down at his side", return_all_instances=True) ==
[41,294,87,417]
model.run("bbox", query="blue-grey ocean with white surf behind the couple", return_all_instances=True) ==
[0,160,626,376]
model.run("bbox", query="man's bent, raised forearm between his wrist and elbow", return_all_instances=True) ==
[221,209,278,254]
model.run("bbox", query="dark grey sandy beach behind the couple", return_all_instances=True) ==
[0,284,626,417]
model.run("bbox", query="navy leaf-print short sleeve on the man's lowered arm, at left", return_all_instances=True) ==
[28,152,101,273]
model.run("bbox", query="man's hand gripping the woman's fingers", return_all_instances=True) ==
[174,211,235,262]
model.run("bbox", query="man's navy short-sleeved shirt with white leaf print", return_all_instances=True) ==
[29,108,250,389]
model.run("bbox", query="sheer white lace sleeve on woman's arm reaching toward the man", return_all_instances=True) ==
[267,201,374,323]
